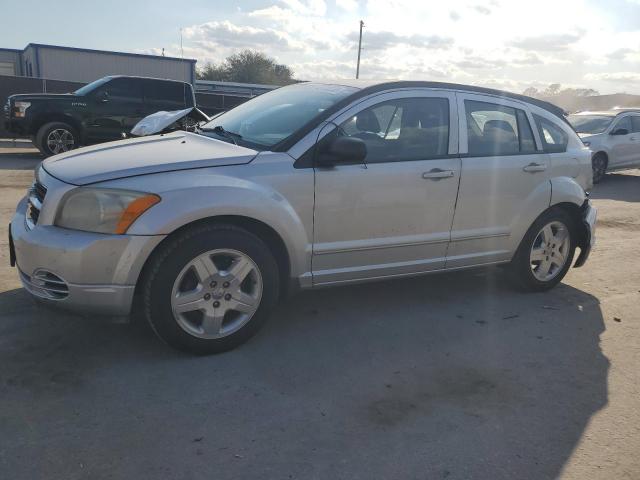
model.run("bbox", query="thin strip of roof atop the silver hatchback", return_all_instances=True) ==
[312,80,567,122]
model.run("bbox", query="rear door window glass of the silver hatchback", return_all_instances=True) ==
[464,100,536,157]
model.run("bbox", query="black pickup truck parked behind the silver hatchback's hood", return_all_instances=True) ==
[5,76,195,157]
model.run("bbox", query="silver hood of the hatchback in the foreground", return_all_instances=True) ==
[42,132,258,185]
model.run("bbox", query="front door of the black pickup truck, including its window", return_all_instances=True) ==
[87,78,144,143]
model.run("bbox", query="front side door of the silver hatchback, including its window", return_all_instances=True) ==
[312,90,460,285]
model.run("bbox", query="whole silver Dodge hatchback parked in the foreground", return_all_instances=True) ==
[10,82,596,353]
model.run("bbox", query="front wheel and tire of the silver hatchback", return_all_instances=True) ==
[142,224,280,355]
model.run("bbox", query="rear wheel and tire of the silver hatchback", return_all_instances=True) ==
[511,208,577,292]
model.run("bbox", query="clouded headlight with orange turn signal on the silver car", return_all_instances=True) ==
[55,187,160,234]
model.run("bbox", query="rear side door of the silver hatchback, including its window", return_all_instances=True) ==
[447,93,551,268]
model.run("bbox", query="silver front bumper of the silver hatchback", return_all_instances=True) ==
[9,200,165,316]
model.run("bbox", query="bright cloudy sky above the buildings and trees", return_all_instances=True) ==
[0,0,640,94]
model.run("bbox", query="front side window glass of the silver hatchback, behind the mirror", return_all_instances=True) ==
[337,97,449,163]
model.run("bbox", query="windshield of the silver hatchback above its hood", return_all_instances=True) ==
[203,83,357,148]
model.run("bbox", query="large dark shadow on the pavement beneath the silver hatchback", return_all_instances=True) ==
[0,269,609,480]
